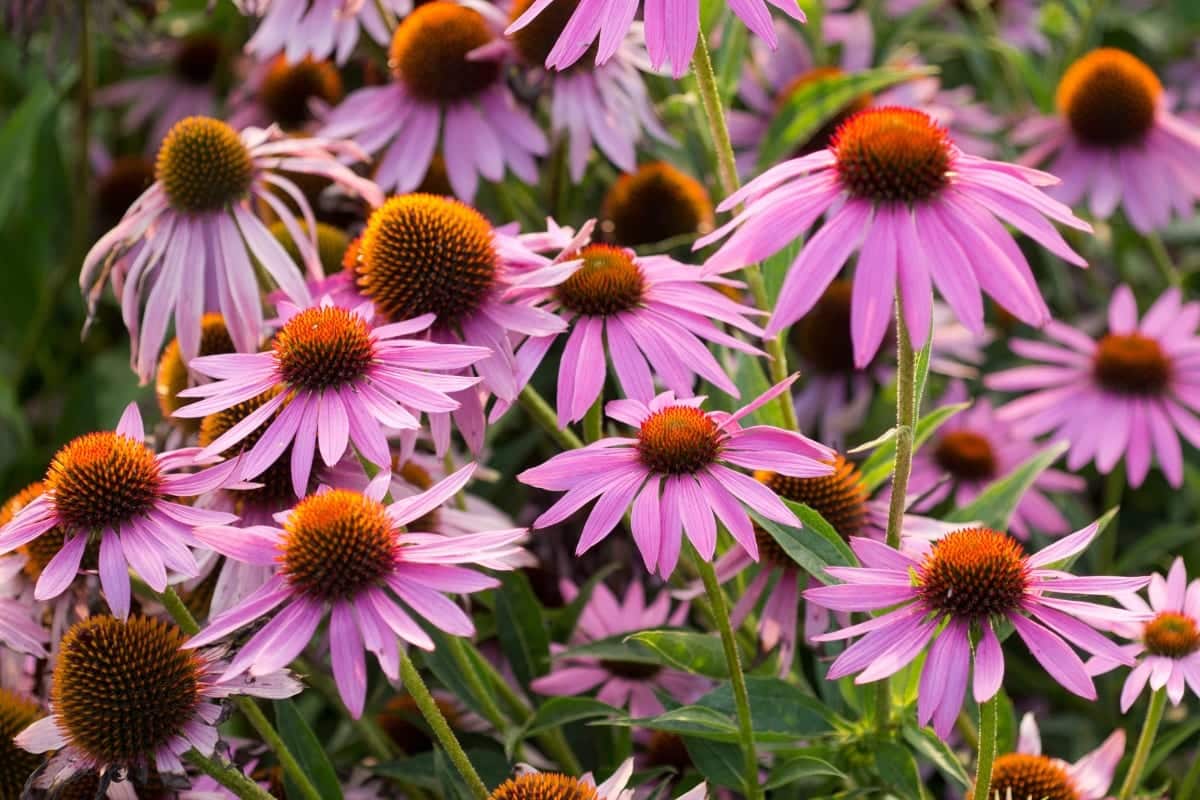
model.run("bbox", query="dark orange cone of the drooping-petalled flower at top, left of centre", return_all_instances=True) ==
[388,0,500,103]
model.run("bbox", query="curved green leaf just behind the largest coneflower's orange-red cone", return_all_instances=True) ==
[758,67,936,172]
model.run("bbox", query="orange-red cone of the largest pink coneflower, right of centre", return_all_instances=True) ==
[829,107,953,204]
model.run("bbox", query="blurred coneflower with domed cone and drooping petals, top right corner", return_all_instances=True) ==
[1013,47,1200,233]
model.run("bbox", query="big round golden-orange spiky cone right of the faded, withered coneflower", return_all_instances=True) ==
[355,194,499,324]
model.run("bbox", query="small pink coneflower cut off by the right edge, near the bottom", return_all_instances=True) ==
[1087,557,1200,714]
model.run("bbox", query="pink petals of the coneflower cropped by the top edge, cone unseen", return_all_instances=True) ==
[504,0,804,79]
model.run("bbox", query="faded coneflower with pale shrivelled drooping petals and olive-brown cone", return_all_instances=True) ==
[79,116,383,380]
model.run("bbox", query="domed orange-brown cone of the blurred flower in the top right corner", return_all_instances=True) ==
[1055,47,1163,148]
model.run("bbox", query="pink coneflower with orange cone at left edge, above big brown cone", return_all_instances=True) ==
[0,403,238,619]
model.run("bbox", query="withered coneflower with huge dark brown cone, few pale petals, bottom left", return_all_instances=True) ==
[16,616,301,788]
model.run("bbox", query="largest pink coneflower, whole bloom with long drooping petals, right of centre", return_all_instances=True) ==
[696,108,1091,366]
